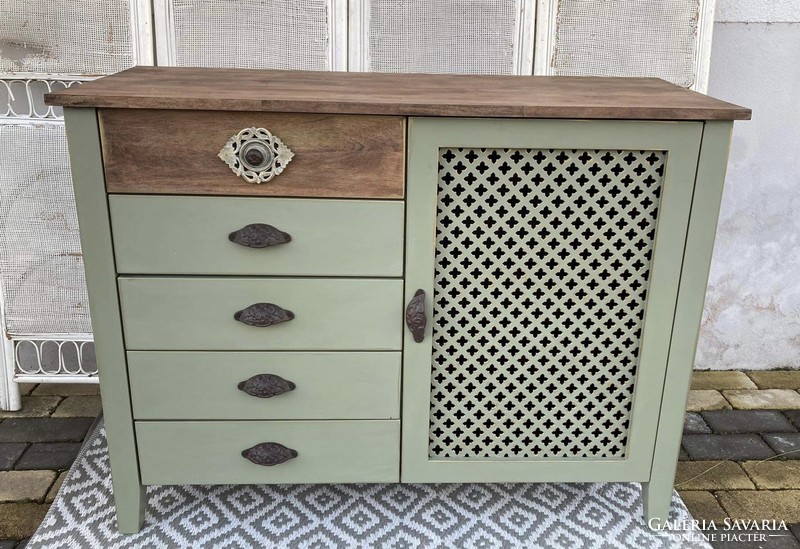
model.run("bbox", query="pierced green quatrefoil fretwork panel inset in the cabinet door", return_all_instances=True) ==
[429,144,667,459]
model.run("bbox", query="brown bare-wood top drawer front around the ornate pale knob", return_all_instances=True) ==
[100,109,405,198]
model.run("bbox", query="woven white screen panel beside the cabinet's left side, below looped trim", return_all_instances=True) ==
[0,123,91,335]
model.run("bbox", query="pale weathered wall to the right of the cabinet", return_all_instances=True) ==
[695,0,800,369]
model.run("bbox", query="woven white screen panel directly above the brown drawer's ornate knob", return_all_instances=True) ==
[155,0,345,70]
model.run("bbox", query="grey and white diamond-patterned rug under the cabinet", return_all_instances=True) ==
[27,422,710,549]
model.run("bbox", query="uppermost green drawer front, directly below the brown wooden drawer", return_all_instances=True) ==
[109,195,404,276]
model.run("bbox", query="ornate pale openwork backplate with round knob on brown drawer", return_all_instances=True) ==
[217,128,294,183]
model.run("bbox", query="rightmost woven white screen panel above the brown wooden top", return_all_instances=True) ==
[537,0,713,88]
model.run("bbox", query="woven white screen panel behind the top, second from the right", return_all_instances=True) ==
[349,0,534,74]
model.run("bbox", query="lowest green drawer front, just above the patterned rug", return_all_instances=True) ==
[136,420,400,484]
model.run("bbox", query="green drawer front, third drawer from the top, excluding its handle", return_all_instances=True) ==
[119,277,403,351]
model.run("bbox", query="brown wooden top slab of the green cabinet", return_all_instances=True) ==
[45,67,750,120]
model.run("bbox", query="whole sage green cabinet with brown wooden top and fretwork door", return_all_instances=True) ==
[48,68,749,532]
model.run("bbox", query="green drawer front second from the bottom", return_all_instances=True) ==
[128,351,400,419]
